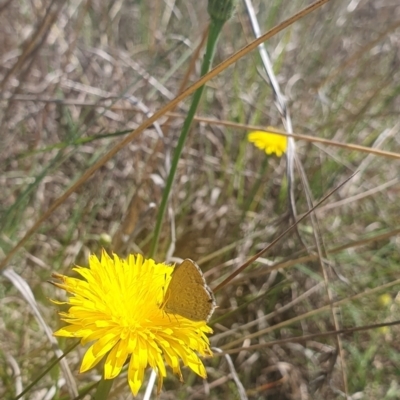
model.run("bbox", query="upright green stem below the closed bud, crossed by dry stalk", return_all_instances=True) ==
[150,19,225,258]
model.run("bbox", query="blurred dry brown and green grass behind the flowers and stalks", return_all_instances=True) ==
[0,0,400,399]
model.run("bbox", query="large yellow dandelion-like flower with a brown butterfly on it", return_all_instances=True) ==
[53,251,212,395]
